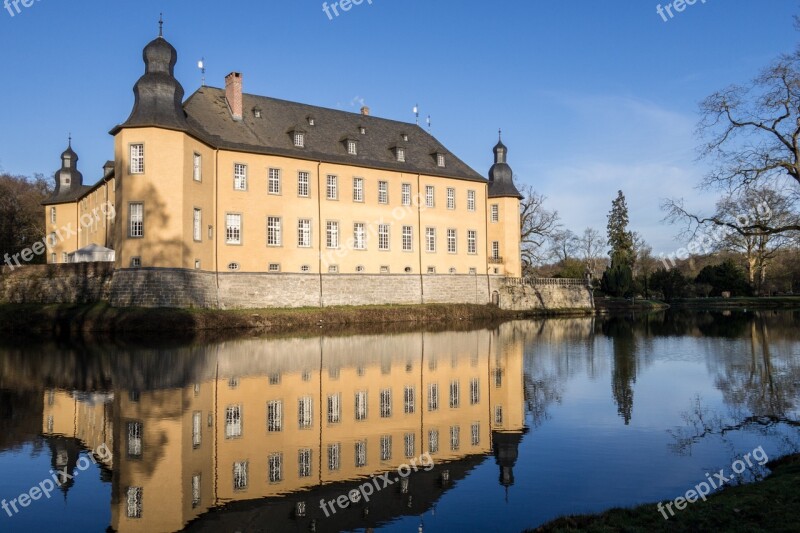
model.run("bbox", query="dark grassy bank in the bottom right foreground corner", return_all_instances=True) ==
[532,455,800,533]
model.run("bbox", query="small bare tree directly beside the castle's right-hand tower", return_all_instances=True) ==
[520,185,560,271]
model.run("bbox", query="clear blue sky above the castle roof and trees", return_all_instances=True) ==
[0,0,800,252]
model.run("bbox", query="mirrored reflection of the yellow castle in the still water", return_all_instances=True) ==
[43,324,525,532]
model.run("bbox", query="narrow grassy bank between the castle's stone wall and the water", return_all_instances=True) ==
[0,303,594,336]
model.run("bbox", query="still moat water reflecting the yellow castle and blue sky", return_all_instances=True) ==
[0,311,800,532]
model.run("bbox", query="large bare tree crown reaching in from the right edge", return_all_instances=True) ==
[663,43,800,237]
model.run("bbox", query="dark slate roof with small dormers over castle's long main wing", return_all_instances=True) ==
[178,87,487,182]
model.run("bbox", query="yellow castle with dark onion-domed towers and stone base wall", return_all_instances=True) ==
[45,27,522,307]
